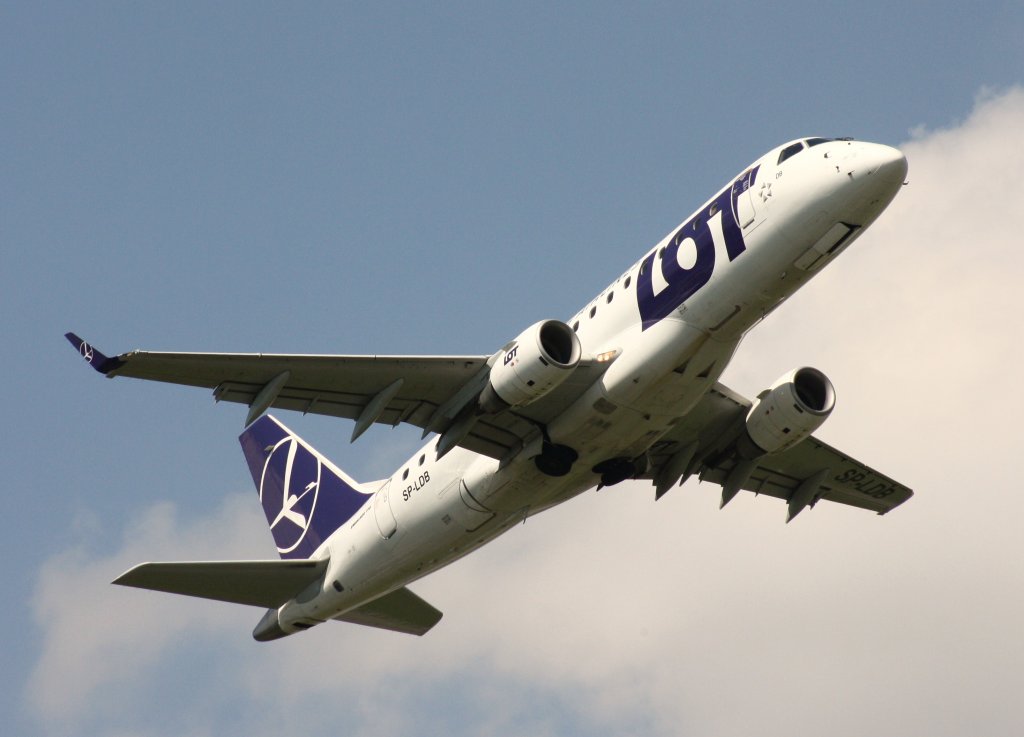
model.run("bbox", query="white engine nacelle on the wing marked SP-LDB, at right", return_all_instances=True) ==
[739,367,836,459]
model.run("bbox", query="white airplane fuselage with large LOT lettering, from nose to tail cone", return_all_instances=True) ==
[279,139,906,632]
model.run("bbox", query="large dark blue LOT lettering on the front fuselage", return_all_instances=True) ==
[637,167,758,330]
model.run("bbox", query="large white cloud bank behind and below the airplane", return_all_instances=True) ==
[28,88,1024,736]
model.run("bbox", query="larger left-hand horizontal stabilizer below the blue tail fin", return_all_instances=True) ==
[114,560,328,609]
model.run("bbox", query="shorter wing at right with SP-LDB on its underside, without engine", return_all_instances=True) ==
[641,384,913,522]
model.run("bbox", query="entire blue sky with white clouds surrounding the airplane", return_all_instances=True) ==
[6,1,1024,737]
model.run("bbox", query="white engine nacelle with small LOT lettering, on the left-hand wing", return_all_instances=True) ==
[480,320,583,413]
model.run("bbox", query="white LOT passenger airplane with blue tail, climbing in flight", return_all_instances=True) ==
[66,137,912,641]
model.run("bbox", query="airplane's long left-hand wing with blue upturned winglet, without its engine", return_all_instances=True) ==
[66,333,608,459]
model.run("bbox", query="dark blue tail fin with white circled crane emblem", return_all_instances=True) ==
[239,415,371,558]
